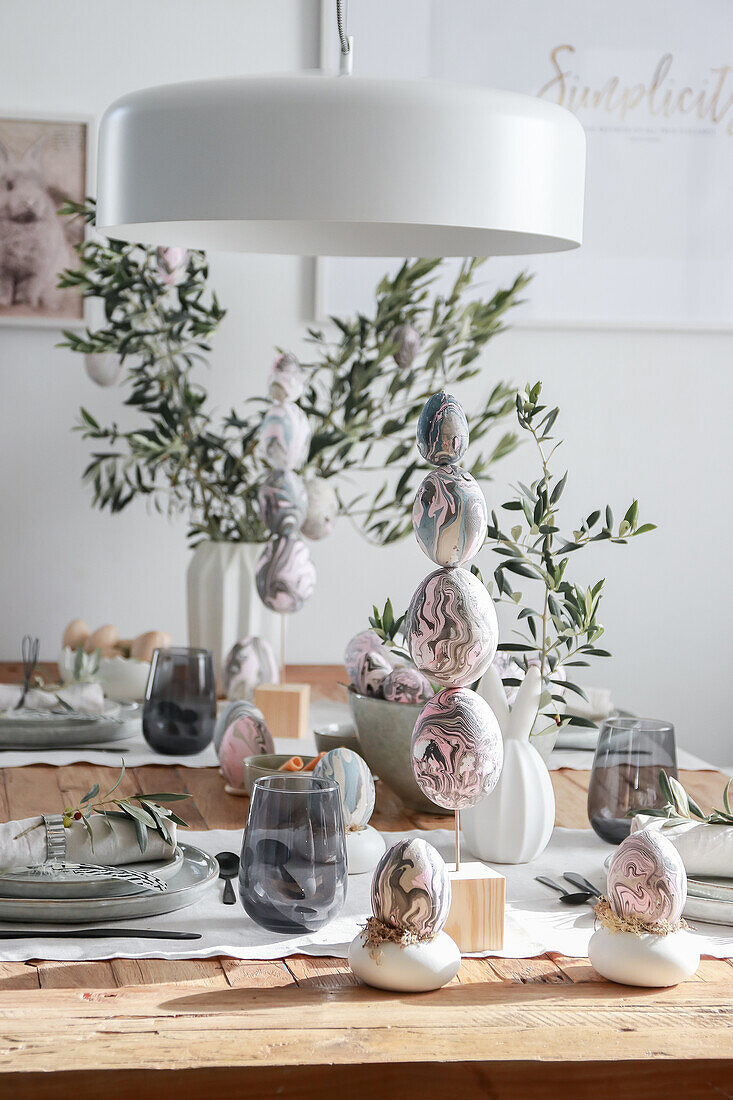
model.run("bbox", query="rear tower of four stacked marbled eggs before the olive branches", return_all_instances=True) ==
[256,355,316,615]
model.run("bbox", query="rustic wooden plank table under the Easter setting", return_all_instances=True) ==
[0,670,733,1100]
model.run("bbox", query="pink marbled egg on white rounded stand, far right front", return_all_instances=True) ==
[588,829,700,988]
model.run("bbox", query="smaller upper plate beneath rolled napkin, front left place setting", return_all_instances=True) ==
[0,846,184,901]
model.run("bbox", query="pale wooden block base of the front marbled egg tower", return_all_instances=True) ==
[445,862,506,952]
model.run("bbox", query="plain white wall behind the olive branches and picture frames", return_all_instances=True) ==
[0,0,733,762]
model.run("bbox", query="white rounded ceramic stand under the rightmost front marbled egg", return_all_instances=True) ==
[588,927,700,988]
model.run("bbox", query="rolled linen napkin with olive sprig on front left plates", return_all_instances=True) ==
[0,814,176,871]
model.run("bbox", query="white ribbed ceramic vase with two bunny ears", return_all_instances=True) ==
[461,668,555,864]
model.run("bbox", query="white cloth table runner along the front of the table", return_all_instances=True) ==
[0,828,733,961]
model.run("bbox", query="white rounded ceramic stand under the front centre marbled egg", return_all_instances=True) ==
[349,932,461,993]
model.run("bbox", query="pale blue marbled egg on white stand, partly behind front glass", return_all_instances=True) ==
[314,747,384,875]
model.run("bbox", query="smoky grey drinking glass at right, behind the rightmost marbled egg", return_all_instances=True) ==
[588,718,677,844]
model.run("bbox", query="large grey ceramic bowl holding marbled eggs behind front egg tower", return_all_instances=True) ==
[348,689,446,814]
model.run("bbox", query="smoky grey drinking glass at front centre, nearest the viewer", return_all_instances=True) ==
[239,776,347,935]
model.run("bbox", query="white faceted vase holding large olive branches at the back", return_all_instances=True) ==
[186,542,281,675]
